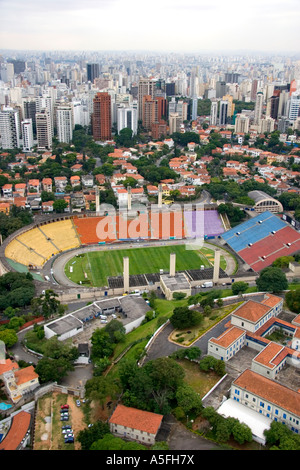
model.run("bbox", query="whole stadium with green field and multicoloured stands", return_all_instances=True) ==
[0,205,300,290]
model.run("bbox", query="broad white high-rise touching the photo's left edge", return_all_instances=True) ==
[0,107,21,149]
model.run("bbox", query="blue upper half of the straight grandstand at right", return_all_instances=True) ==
[222,211,286,252]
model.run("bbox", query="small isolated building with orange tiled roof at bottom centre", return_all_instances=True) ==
[109,405,163,445]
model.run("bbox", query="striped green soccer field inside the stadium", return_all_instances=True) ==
[65,245,226,287]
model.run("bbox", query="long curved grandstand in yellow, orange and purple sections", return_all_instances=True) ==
[5,210,224,269]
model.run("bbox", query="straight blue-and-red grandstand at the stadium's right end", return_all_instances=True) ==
[222,211,300,272]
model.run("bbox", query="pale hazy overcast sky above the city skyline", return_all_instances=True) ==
[0,0,300,52]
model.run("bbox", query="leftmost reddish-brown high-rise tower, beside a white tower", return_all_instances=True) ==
[92,92,112,141]
